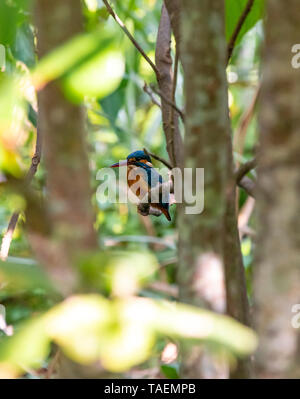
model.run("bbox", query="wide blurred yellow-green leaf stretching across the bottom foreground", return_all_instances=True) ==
[0,295,257,373]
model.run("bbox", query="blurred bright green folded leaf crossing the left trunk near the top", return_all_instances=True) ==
[33,28,125,102]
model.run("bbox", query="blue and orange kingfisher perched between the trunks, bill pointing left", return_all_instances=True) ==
[111,151,171,221]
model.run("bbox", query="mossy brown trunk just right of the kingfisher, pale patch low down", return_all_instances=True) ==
[178,0,230,378]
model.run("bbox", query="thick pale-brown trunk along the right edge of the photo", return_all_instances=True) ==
[254,0,300,378]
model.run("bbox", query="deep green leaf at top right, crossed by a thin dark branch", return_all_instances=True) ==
[225,0,265,44]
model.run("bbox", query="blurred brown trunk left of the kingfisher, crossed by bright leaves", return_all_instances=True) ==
[34,0,101,378]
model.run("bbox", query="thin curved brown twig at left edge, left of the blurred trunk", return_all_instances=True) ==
[0,122,42,261]
